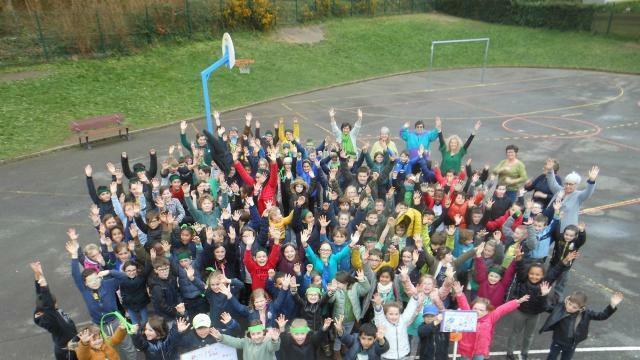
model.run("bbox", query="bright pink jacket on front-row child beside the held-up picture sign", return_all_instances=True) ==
[456,294,520,358]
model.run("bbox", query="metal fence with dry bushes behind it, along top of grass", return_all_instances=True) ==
[0,0,432,66]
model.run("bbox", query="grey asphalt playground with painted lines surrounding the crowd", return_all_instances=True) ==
[0,68,640,359]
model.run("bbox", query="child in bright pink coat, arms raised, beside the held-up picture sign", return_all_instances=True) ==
[453,282,532,360]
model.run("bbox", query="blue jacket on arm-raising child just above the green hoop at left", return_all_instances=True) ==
[71,259,118,324]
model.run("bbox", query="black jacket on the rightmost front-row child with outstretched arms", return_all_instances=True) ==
[540,302,616,345]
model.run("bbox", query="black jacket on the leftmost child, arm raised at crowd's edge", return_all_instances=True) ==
[33,281,78,349]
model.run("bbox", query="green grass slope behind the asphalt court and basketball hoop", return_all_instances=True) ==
[0,14,640,159]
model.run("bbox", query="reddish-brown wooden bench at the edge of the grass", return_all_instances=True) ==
[69,114,129,149]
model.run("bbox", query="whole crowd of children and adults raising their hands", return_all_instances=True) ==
[31,109,623,360]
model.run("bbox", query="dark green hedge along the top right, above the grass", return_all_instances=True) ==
[434,0,603,30]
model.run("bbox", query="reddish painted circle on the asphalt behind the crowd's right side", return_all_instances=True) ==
[502,115,602,139]
